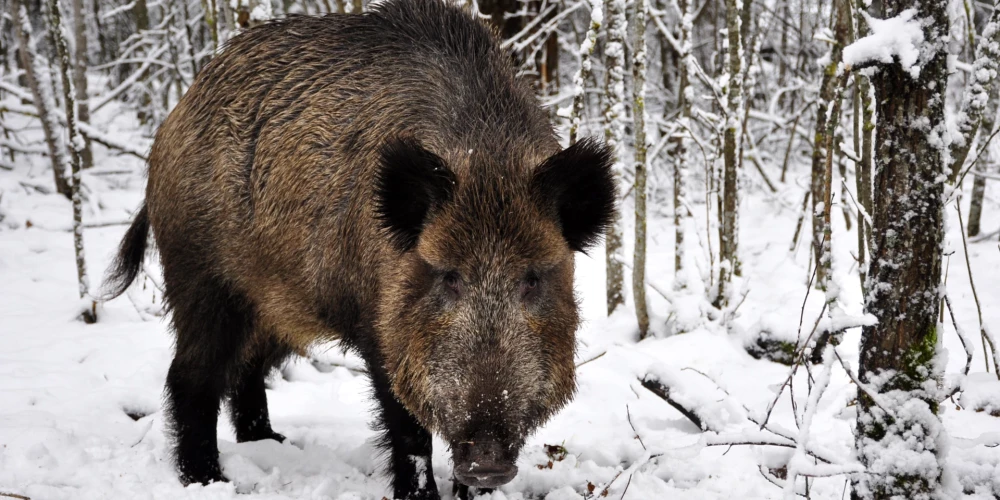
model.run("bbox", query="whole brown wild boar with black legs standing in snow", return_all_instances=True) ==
[103,0,614,498]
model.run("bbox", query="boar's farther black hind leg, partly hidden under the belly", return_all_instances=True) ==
[229,340,290,443]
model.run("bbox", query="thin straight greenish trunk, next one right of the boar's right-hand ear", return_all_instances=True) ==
[632,0,649,339]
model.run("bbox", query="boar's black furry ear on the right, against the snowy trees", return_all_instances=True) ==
[531,139,617,252]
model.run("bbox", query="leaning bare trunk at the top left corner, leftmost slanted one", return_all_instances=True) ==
[10,0,72,198]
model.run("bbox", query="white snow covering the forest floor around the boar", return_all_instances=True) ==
[0,110,1000,500]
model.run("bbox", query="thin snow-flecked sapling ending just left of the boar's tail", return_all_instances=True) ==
[48,0,97,323]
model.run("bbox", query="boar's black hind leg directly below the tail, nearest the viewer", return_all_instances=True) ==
[164,278,251,484]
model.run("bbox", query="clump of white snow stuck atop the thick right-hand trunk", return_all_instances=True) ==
[844,9,924,79]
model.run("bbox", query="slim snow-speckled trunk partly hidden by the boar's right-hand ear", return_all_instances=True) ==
[604,0,628,315]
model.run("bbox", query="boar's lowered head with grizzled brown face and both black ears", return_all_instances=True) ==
[376,135,615,487]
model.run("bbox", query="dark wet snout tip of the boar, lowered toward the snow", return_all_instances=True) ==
[451,441,517,488]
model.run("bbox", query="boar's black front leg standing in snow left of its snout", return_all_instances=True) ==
[368,363,440,500]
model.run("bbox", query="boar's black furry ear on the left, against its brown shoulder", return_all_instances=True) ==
[375,138,455,251]
